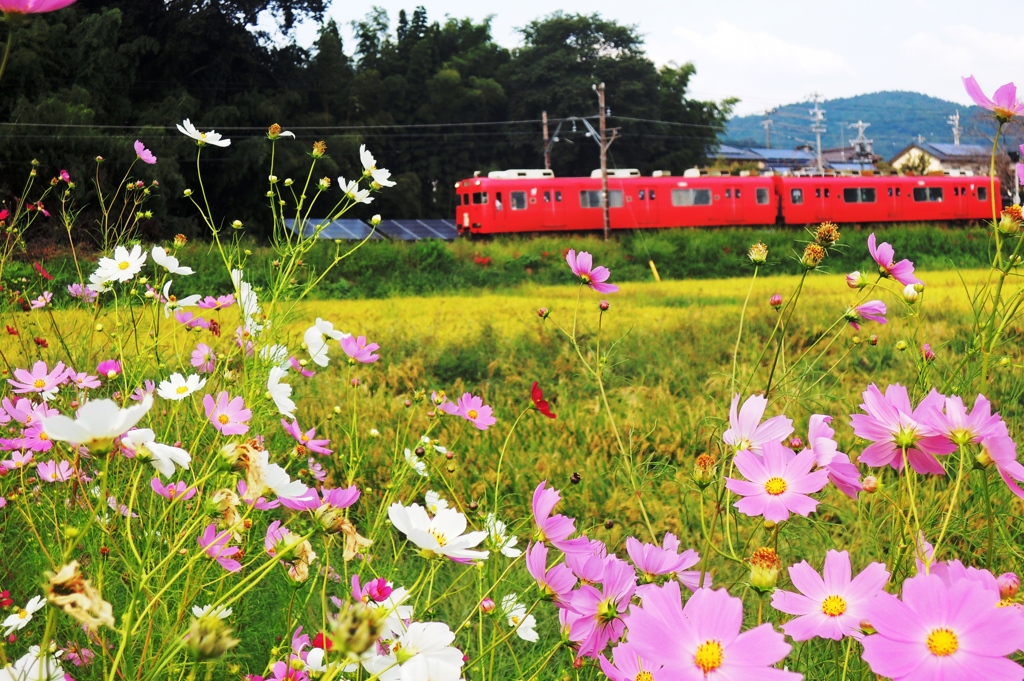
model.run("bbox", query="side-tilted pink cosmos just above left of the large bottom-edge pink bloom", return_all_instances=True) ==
[567,556,637,657]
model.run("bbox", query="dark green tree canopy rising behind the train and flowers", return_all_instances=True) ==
[0,0,733,237]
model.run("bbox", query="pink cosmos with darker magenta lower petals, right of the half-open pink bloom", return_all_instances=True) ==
[850,383,956,475]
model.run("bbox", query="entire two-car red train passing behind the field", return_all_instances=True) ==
[456,170,999,235]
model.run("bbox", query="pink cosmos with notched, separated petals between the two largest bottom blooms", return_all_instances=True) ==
[771,551,889,641]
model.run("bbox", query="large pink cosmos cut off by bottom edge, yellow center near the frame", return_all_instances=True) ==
[628,582,803,681]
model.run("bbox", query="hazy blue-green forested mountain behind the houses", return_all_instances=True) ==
[723,91,995,160]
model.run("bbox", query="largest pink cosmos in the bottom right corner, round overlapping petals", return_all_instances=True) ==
[863,574,1024,681]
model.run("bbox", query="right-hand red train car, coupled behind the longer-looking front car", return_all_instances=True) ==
[773,175,999,224]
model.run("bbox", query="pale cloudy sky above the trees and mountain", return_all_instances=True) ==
[282,0,1024,116]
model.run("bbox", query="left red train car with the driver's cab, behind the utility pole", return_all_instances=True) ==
[456,170,778,235]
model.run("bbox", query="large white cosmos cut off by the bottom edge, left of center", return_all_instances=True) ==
[362,622,464,681]
